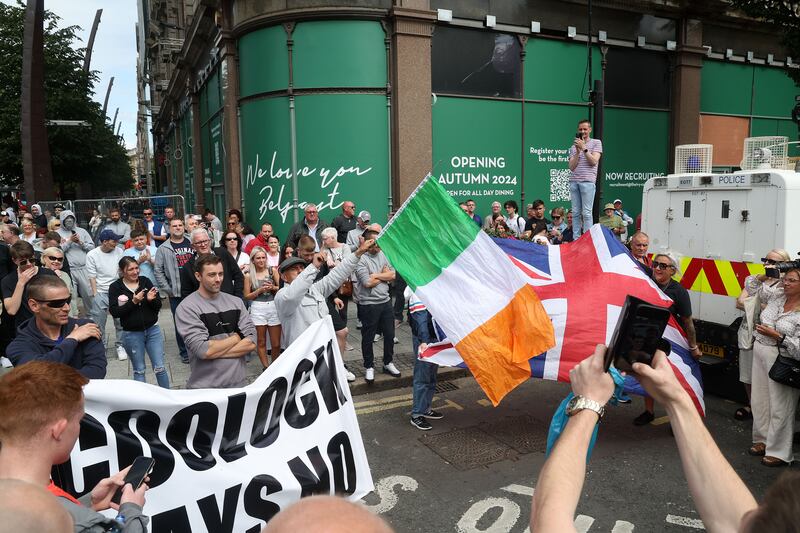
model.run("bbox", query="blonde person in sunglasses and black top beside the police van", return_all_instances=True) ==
[633,254,703,426]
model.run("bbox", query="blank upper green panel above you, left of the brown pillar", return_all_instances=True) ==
[292,20,386,88]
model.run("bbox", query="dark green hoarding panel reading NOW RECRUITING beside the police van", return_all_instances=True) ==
[601,108,669,219]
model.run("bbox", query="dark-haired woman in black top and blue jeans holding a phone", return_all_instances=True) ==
[108,256,169,389]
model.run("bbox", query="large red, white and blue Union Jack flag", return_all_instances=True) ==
[420,224,705,414]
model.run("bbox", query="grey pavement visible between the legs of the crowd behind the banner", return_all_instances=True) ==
[101,300,467,396]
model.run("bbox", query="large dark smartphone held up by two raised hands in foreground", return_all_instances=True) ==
[605,295,670,372]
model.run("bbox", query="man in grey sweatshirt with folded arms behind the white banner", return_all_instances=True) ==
[175,254,256,389]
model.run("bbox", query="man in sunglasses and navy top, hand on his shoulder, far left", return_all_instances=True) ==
[6,276,107,379]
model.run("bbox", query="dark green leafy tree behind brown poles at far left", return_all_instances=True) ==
[0,4,132,198]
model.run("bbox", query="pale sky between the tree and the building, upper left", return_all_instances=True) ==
[0,0,137,148]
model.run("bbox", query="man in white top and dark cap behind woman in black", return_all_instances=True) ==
[86,229,128,361]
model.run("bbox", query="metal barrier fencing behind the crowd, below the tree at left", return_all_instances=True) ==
[72,194,186,238]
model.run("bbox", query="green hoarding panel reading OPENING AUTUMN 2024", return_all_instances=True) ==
[432,97,524,220]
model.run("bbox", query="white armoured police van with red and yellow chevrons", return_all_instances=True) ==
[642,143,800,397]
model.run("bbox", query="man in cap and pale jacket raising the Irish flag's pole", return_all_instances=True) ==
[275,239,375,345]
